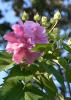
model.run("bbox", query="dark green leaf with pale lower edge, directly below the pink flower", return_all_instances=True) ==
[4,64,33,81]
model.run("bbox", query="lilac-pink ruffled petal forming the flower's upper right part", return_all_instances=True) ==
[24,21,48,44]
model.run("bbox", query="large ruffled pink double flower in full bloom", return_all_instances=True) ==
[4,21,48,64]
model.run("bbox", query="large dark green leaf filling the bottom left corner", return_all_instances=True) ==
[0,80,24,100]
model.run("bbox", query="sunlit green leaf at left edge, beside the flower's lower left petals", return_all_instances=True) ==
[0,52,15,71]
